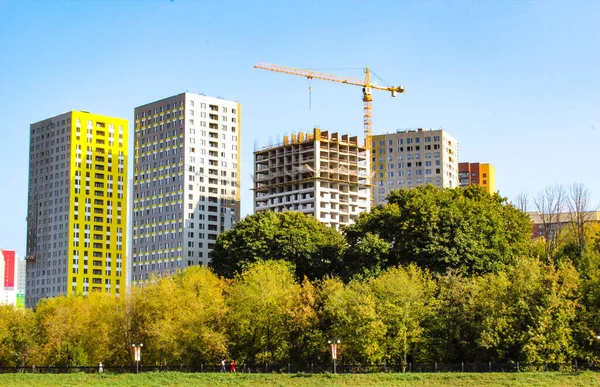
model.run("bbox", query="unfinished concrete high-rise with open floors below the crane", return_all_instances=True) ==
[254,128,370,228]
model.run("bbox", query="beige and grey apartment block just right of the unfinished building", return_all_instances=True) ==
[371,129,458,205]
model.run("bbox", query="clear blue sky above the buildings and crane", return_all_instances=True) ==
[0,0,600,256]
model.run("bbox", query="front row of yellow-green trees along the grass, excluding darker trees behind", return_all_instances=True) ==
[0,258,600,366]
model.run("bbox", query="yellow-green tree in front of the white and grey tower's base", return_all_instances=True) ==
[130,266,227,365]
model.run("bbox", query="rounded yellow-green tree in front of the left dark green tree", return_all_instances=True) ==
[227,261,314,364]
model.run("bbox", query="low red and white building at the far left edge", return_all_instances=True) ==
[0,249,25,308]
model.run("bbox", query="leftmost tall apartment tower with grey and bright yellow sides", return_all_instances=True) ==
[26,111,128,307]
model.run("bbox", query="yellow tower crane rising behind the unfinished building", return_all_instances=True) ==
[254,63,404,148]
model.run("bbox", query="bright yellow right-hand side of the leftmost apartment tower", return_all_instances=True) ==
[68,111,129,295]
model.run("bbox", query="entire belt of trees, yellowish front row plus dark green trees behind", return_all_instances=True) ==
[0,187,600,366]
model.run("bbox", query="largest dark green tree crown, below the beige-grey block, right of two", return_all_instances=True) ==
[344,185,531,275]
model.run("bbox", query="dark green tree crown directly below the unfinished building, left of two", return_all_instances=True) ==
[210,211,346,280]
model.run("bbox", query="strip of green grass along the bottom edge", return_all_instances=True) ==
[0,372,600,387]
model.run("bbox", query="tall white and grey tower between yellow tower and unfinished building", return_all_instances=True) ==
[131,93,241,285]
